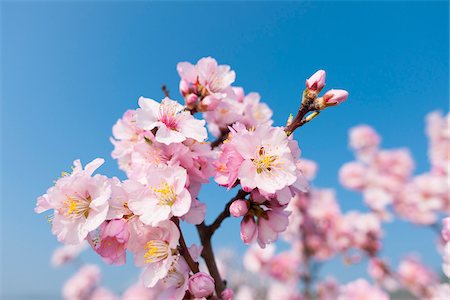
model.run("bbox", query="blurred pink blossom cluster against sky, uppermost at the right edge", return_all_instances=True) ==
[339,112,450,225]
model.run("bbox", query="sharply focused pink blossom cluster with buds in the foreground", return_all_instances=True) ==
[35,57,347,299]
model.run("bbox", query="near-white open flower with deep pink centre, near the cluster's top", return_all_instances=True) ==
[136,97,207,145]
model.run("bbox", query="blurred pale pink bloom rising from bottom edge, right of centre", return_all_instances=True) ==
[337,279,389,300]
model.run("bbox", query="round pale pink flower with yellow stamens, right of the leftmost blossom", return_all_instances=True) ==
[129,165,192,226]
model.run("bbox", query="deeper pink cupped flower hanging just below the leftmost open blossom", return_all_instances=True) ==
[88,219,130,265]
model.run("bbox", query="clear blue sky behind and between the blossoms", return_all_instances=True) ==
[0,1,449,299]
